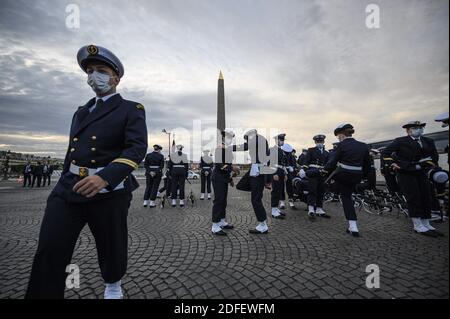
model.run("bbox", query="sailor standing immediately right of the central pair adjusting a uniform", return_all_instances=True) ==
[270,133,287,219]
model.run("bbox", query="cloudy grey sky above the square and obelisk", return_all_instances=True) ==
[0,0,449,157]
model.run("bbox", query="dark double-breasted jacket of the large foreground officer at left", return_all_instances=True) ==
[53,94,147,202]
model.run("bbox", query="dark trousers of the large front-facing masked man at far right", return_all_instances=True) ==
[397,171,431,219]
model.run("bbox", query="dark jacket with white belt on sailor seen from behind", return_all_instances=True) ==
[324,137,371,178]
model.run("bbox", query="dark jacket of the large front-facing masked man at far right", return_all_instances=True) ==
[382,136,439,171]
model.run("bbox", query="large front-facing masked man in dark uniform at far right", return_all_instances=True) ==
[382,121,442,237]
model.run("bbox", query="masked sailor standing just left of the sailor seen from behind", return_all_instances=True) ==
[300,134,330,220]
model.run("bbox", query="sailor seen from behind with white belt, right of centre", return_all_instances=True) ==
[324,124,370,237]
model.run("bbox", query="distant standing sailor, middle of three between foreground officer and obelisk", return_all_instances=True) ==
[169,145,189,207]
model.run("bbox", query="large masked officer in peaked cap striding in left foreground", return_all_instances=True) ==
[26,45,147,299]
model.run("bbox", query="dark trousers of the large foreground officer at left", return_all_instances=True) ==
[25,193,132,298]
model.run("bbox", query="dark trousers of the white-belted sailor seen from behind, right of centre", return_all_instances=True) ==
[333,172,362,220]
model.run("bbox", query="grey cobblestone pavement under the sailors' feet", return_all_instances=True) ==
[0,181,449,298]
